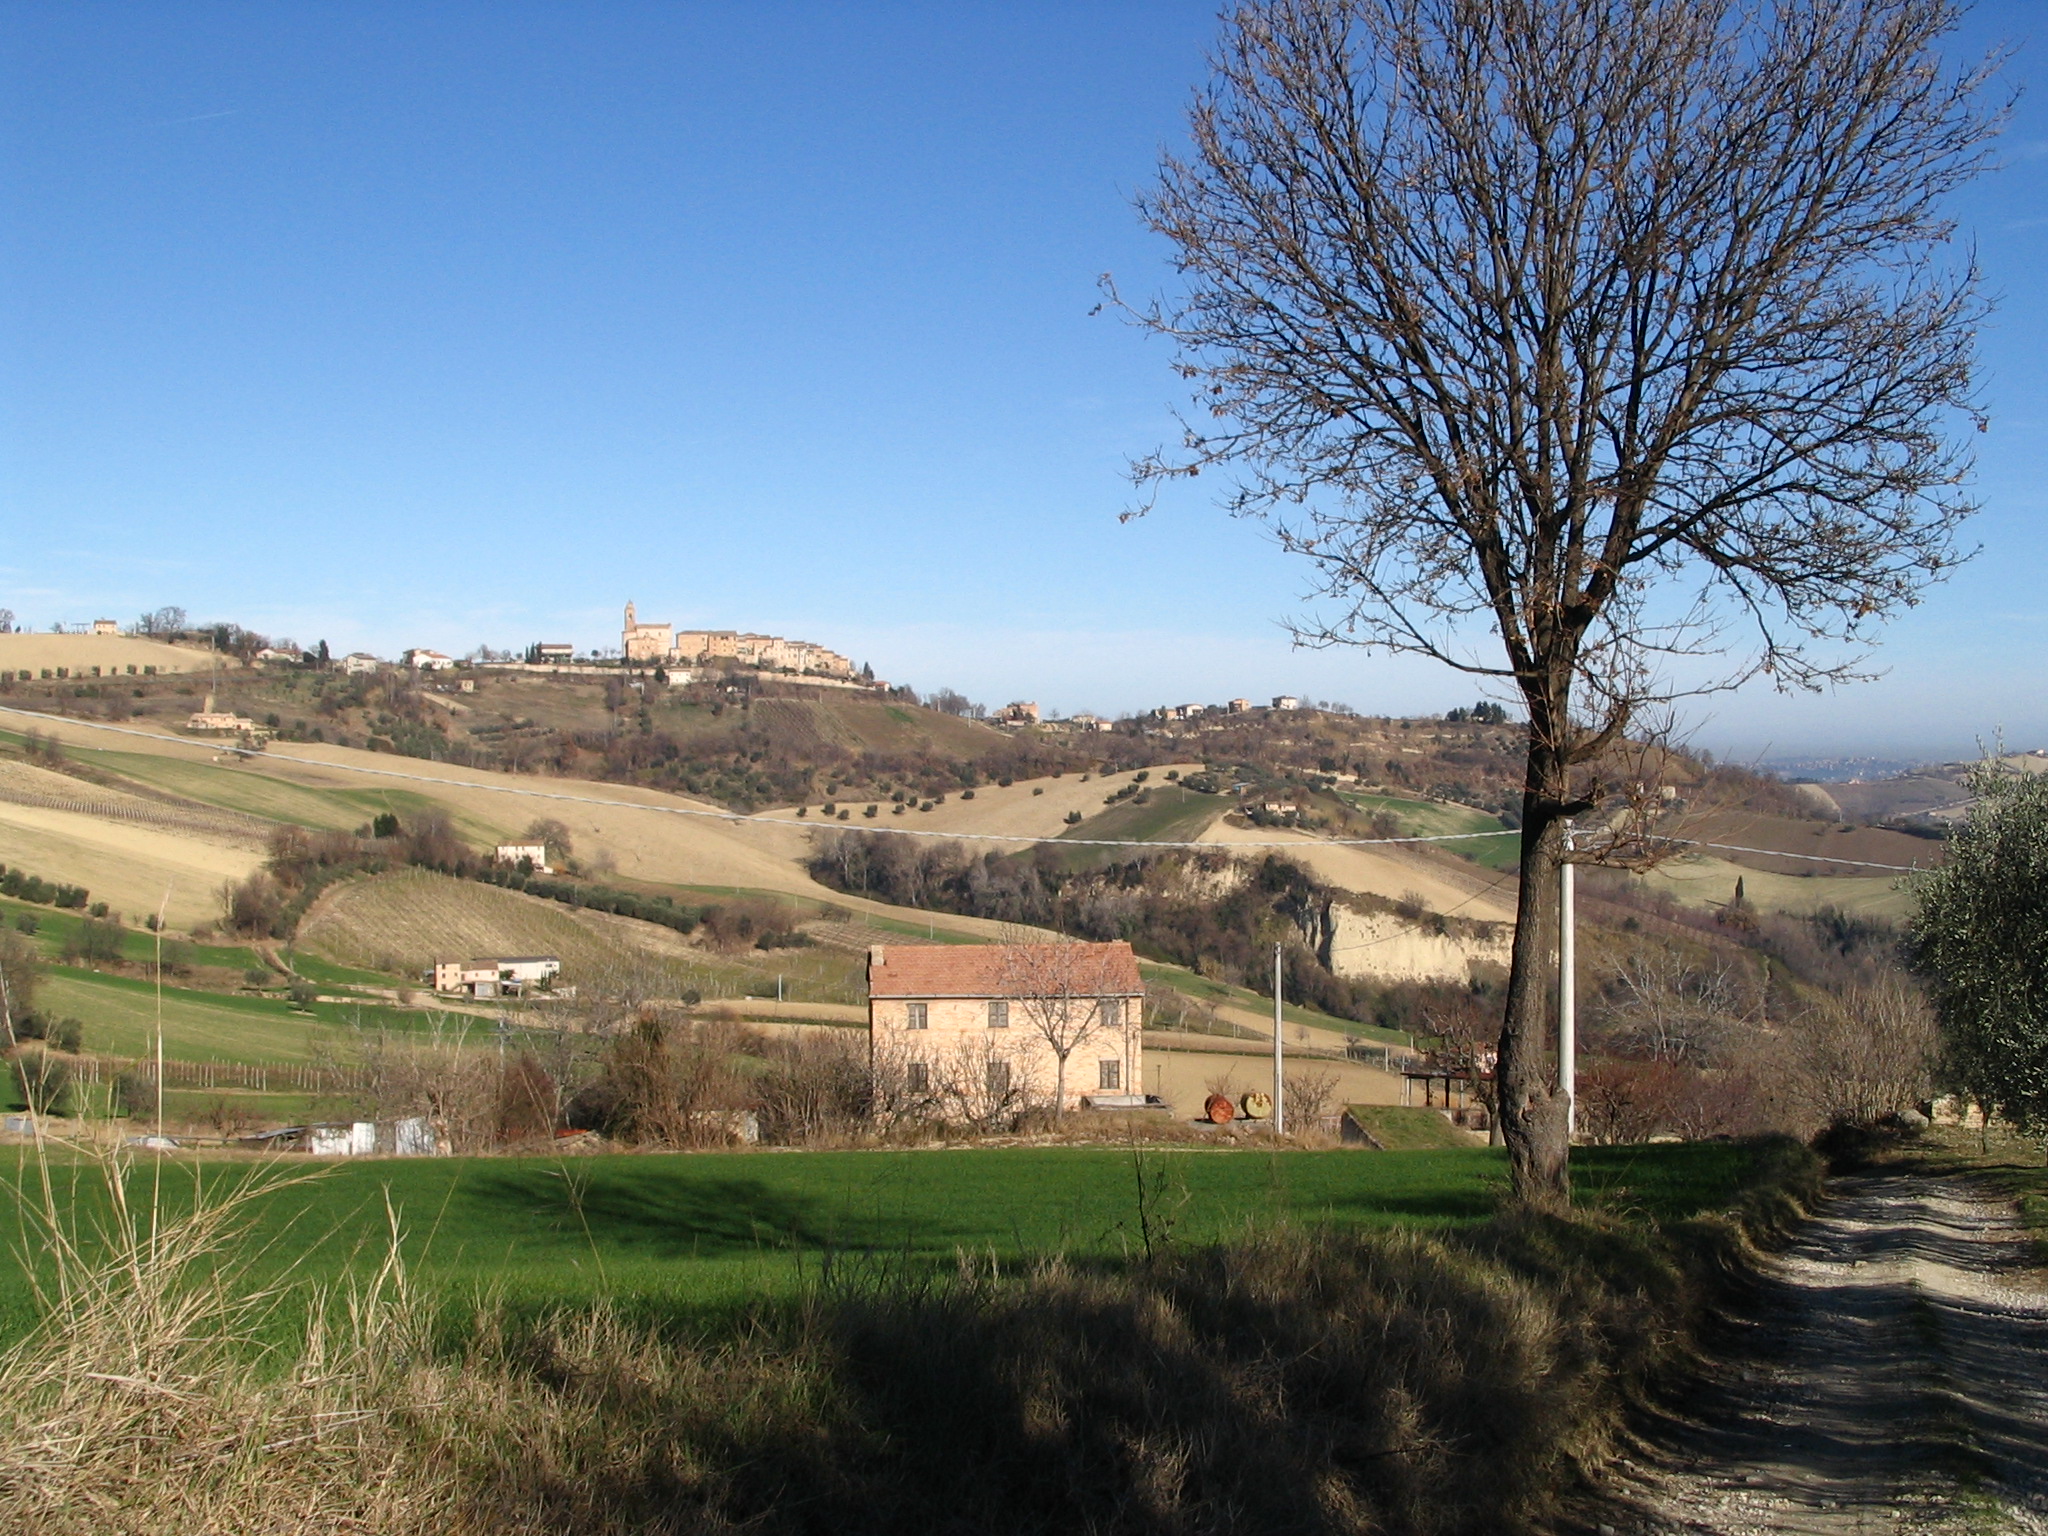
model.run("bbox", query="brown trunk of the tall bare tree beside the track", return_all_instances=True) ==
[1493,753,1571,1204]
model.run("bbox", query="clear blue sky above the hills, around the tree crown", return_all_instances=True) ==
[0,0,2048,756]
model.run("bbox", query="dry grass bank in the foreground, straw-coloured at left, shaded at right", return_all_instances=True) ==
[0,1159,1806,1536]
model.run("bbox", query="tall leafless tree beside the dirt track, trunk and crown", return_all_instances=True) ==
[1135,0,2001,1200]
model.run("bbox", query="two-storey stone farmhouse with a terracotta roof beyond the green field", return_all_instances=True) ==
[868,942,1145,1120]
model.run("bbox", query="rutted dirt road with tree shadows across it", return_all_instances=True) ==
[1597,1174,2048,1536]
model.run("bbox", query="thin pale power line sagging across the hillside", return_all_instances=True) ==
[0,705,1925,874]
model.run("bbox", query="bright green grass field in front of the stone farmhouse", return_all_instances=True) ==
[0,1143,1757,1333]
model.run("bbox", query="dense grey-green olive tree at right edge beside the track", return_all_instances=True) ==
[1913,768,2048,1135]
